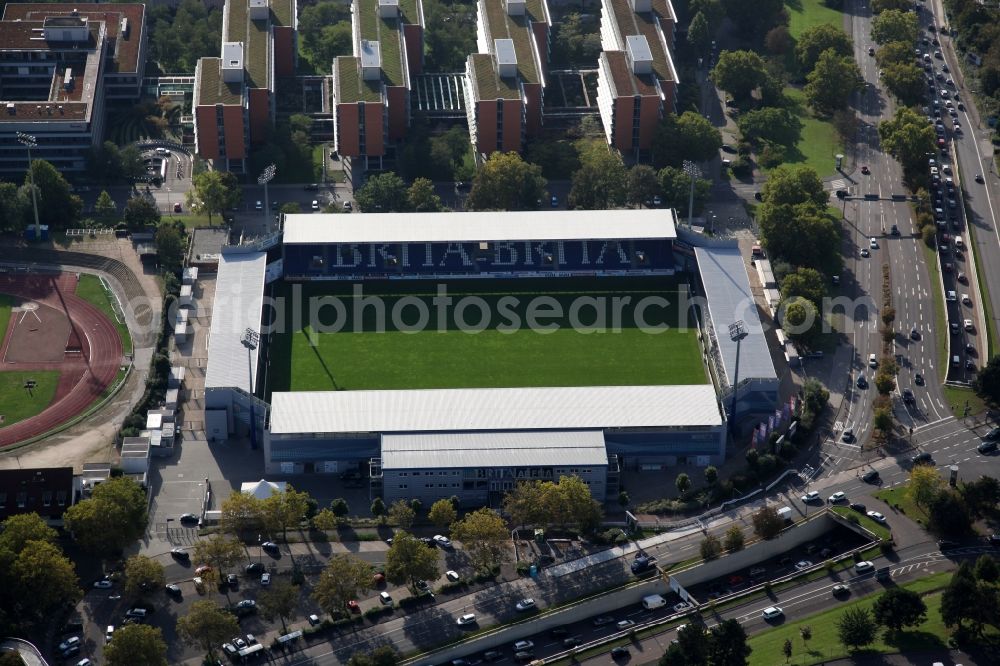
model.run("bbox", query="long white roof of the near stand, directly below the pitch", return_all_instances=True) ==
[266,384,722,435]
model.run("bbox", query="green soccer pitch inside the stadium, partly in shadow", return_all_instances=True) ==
[267,277,708,392]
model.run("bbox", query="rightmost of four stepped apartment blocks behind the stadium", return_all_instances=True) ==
[597,0,678,158]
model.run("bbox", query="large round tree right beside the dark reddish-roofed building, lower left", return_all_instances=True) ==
[64,476,147,554]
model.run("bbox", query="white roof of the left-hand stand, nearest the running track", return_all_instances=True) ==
[205,252,267,393]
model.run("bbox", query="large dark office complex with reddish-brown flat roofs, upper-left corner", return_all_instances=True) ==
[0,3,146,177]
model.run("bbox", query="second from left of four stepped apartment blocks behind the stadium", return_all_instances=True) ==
[333,0,424,172]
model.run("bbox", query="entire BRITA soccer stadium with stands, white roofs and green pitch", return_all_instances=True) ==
[206,210,777,506]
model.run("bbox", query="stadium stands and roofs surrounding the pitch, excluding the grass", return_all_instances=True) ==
[206,210,778,506]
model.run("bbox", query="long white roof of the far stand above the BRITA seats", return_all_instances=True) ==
[283,208,677,245]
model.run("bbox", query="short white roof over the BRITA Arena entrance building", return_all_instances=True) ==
[382,430,608,469]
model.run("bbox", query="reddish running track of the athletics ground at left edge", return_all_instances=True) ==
[0,273,123,447]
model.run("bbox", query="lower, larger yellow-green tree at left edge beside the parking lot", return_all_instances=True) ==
[7,540,83,621]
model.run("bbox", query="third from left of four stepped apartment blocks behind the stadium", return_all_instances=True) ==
[465,0,552,156]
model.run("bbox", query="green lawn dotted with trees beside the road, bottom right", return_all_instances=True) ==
[748,572,951,666]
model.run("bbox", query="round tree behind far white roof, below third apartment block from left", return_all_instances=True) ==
[466,152,546,210]
